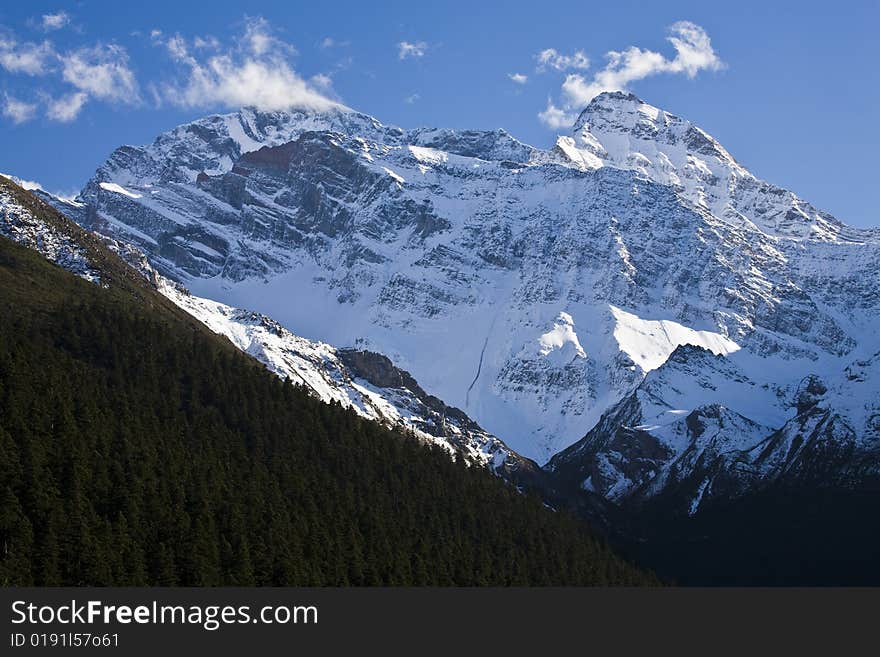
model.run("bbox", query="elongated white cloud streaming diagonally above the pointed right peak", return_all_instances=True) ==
[538,21,724,128]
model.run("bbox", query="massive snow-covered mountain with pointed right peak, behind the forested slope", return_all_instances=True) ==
[46,93,880,506]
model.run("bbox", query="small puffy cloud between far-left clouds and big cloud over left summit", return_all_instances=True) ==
[61,44,140,104]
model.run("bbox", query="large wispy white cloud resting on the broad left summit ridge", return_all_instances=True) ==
[162,18,338,110]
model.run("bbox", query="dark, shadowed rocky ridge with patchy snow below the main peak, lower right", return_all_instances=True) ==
[548,346,880,515]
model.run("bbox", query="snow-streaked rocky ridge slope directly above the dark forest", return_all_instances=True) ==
[0,180,540,483]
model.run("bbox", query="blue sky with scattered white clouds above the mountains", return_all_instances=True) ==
[0,0,880,226]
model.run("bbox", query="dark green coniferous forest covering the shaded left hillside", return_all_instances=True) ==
[0,238,655,586]
